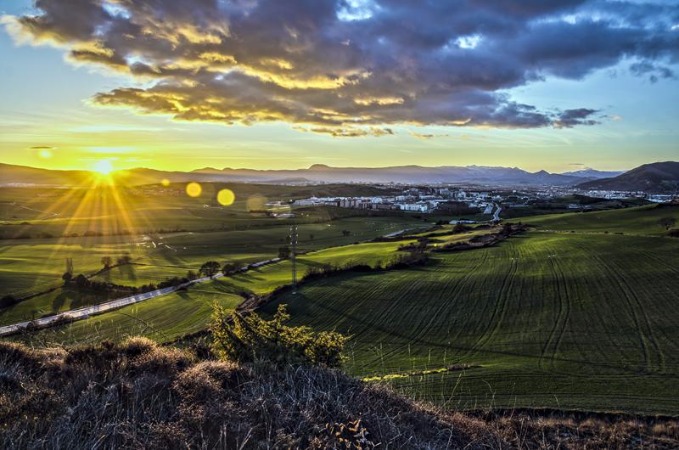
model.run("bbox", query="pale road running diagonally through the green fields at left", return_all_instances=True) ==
[0,258,280,336]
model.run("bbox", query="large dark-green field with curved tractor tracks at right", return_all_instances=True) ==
[265,233,679,413]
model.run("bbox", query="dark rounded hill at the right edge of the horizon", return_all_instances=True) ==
[578,161,679,193]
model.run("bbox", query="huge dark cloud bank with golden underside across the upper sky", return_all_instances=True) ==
[1,0,679,137]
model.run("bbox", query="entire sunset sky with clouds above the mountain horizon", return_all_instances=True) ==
[0,0,679,172]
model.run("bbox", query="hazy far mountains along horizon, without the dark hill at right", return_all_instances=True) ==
[0,164,632,187]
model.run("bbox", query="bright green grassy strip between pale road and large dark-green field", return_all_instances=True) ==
[11,236,420,345]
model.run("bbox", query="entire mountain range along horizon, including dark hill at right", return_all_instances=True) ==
[0,162,679,191]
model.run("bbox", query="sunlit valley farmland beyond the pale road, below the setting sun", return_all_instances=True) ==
[0,179,429,324]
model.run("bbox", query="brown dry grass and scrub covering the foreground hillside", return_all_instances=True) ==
[0,338,679,449]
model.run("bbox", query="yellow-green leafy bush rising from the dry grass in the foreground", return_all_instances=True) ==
[211,305,347,367]
